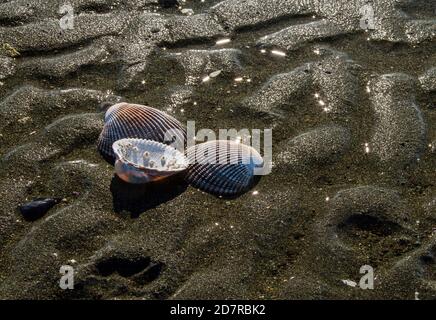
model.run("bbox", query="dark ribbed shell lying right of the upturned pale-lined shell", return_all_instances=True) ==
[185,140,263,196]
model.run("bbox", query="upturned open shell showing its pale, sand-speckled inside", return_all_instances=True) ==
[113,139,188,184]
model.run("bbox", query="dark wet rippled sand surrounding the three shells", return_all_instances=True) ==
[0,0,436,299]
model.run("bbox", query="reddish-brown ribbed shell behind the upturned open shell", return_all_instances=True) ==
[97,102,186,159]
